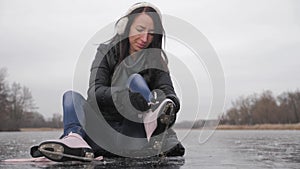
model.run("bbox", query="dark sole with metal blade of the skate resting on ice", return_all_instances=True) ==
[38,142,94,162]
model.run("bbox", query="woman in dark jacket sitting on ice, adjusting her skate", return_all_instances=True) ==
[31,3,184,161]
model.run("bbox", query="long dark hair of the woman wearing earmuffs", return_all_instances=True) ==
[108,6,165,64]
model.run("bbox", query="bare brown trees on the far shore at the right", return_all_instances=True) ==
[220,90,300,125]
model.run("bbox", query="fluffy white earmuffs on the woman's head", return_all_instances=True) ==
[115,2,161,35]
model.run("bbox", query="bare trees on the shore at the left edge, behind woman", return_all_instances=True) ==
[0,68,62,131]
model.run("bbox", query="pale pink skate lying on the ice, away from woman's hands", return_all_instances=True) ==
[38,132,94,162]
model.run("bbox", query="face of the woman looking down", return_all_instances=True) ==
[129,13,154,54]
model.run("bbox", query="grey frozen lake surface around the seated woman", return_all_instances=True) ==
[0,130,300,169]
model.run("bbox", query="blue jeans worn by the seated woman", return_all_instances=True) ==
[61,74,152,141]
